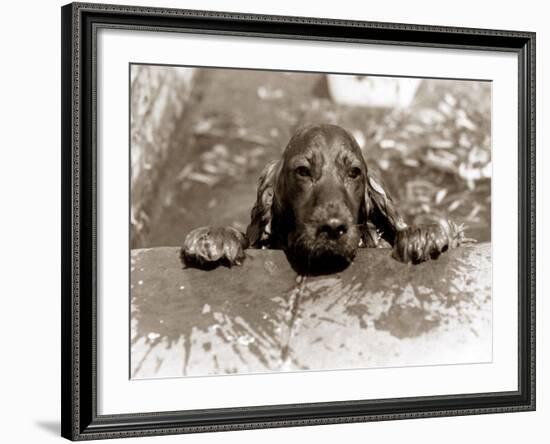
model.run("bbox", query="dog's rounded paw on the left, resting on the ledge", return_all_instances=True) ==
[181,227,248,269]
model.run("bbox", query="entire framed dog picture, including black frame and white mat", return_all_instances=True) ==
[58,3,541,442]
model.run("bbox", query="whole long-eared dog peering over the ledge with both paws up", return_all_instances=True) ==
[181,124,464,274]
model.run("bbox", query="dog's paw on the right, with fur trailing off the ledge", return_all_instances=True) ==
[393,221,475,264]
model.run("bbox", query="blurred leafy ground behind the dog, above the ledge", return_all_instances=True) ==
[130,65,491,248]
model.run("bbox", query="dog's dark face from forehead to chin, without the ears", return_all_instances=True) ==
[272,125,367,268]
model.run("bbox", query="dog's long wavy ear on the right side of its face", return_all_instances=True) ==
[361,171,407,246]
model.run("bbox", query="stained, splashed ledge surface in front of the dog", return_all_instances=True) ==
[131,244,492,379]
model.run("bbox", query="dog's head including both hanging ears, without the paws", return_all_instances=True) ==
[247,125,406,271]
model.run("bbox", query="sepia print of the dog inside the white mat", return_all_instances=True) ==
[128,63,493,380]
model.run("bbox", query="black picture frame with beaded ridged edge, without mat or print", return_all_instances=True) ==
[61,3,535,440]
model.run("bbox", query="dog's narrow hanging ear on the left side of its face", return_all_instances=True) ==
[246,161,279,247]
